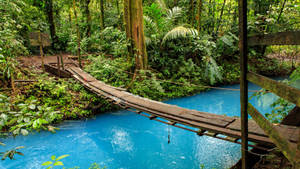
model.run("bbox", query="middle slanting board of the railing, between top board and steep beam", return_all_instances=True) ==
[248,72,300,107]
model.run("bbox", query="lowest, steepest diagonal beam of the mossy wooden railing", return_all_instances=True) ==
[248,103,298,165]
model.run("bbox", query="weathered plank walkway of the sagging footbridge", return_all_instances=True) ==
[62,67,300,148]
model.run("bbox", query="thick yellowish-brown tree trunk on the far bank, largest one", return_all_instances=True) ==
[124,0,148,69]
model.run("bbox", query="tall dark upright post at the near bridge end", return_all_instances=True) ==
[239,0,248,169]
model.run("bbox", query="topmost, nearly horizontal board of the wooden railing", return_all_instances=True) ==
[248,31,300,46]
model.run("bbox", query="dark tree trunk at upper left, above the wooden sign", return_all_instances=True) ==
[45,0,58,49]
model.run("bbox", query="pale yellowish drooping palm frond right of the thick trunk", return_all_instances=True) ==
[162,26,198,44]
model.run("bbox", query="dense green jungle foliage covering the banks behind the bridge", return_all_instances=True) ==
[0,0,300,165]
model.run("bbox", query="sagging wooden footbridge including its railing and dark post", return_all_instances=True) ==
[40,0,300,169]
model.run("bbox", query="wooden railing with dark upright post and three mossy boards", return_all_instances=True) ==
[239,0,300,169]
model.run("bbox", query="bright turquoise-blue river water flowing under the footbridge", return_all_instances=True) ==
[0,84,275,169]
